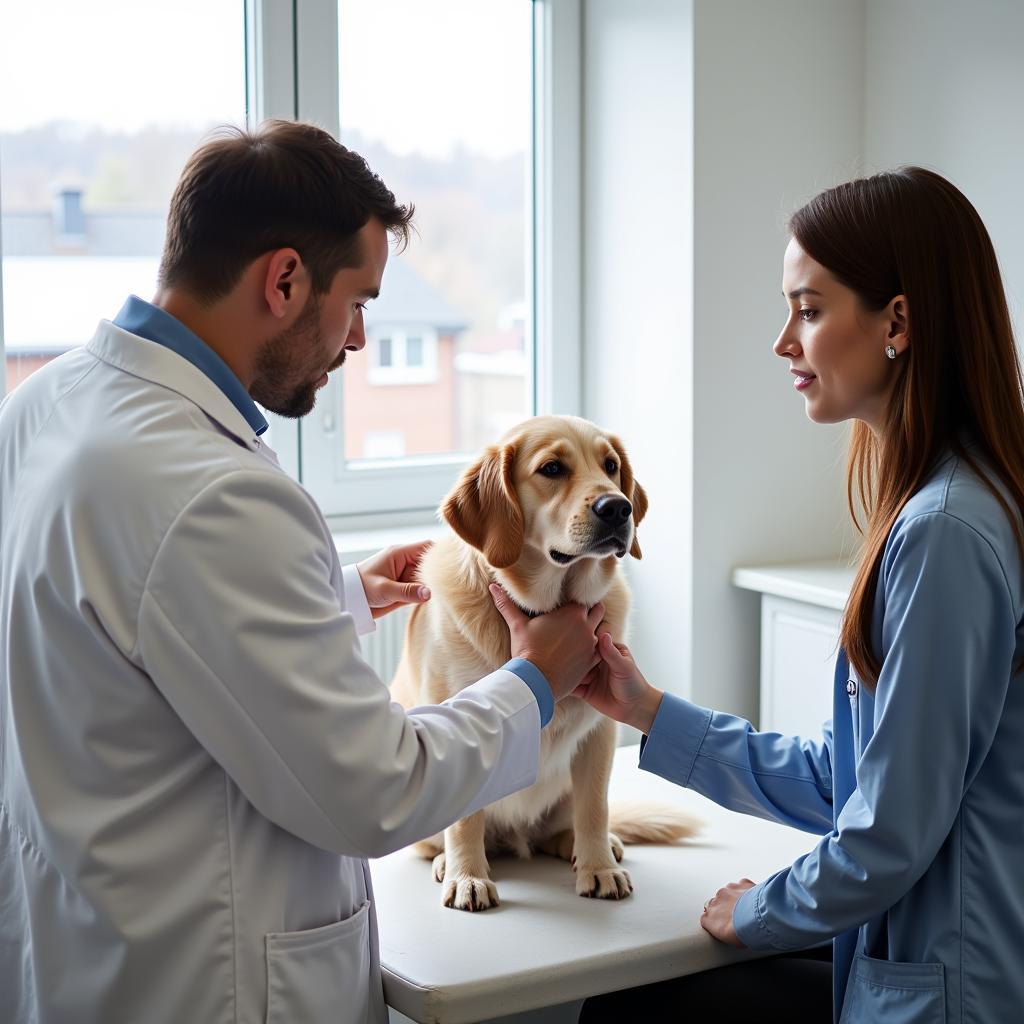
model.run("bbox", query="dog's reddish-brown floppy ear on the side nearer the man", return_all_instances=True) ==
[441,444,523,569]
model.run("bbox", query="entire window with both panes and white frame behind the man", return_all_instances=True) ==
[0,0,580,522]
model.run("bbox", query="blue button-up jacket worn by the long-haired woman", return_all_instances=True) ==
[640,445,1024,1024]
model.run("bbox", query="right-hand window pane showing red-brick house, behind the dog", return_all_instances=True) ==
[300,0,534,512]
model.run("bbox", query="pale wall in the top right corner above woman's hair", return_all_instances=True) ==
[864,0,1024,331]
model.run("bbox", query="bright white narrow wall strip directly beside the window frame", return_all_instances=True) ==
[582,0,693,716]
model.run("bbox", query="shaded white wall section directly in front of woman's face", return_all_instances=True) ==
[691,0,863,721]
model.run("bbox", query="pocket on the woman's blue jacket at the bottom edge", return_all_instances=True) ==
[840,953,946,1024]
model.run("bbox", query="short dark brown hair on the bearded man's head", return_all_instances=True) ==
[159,121,413,303]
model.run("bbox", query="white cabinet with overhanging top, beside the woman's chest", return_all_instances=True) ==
[732,562,854,738]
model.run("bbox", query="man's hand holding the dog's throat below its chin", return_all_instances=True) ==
[490,584,604,700]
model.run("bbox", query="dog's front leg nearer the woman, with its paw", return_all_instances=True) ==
[570,719,633,899]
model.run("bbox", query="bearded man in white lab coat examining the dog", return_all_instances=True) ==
[0,122,603,1024]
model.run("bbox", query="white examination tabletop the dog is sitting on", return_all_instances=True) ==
[372,746,816,1024]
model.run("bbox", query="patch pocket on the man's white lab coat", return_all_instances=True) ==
[266,900,370,1024]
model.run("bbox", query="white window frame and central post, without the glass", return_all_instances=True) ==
[0,0,583,528]
